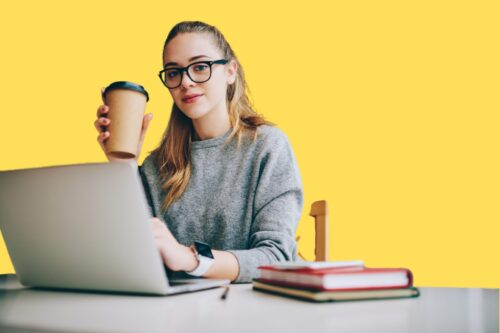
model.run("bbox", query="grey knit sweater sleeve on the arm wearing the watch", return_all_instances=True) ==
[229,131,304,282]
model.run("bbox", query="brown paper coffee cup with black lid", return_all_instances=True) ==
[103,81,149,158]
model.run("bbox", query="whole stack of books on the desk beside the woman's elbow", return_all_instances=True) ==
[253,261,419,302]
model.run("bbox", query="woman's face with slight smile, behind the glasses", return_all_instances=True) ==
[163,33,236,120]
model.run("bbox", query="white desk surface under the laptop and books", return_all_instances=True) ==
[0,276,498,333]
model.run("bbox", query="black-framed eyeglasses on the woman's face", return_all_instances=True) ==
[158,59,228,89]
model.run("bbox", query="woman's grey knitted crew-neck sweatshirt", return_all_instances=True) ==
[140,125,304,282]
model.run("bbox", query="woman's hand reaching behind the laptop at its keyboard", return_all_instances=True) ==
[151,217,198,272]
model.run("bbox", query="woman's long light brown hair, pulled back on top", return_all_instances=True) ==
[152,21,273,212]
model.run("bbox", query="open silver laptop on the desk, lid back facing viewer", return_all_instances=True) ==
[0,162,230,295]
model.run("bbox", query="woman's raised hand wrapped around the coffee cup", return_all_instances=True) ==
[94,88,153,162]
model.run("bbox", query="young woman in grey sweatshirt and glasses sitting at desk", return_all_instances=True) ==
[95,21,303,282]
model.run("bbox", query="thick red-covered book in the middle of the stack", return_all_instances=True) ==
[259,265,413,290]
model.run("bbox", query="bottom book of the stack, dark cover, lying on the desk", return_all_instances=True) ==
[252,279,420,302]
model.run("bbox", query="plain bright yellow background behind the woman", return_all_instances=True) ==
[0,0,500,288]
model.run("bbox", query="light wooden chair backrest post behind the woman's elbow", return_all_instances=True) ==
[309,200,330,261]
